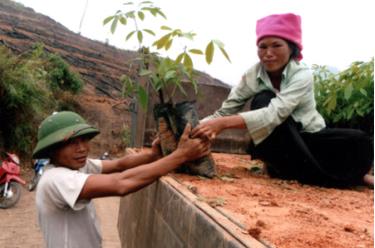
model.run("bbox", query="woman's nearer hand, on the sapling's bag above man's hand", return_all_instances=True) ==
[191,118,223,141]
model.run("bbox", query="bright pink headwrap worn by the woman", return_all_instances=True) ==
[256,13,302,60]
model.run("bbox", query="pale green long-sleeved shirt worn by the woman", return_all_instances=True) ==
[203,60,325,144]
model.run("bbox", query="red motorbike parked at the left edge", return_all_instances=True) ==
[0,153,26,208]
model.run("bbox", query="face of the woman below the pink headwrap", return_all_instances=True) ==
[258,36,292,73]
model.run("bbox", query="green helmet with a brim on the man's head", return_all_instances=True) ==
[33,111,99,158]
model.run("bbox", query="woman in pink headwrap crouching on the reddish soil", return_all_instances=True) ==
[192,13,373,186]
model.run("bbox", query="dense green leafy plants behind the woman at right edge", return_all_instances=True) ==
[313,58,374,134]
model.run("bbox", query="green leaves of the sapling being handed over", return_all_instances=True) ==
[103,1,230,108]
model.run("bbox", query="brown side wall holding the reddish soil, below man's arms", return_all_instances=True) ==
[118,176,265,248]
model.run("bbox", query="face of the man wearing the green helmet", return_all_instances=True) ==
[52,136,90,170]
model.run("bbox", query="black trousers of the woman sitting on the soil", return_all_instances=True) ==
[249,91,373,187]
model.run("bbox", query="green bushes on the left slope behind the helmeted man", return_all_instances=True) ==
[0,44,82,155]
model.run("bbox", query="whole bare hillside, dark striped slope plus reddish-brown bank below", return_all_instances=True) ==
[0,0,239,155]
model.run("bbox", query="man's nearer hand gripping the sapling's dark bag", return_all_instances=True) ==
[176,123,210,160]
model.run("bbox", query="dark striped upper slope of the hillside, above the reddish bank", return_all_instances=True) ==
[0,0,226,98]
